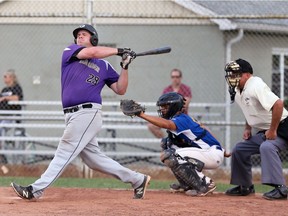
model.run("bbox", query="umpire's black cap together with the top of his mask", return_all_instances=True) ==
[225,58,253,74]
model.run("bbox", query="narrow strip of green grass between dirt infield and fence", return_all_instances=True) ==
[0,177,272,193]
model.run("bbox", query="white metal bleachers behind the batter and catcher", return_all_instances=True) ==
[0,101,287,176]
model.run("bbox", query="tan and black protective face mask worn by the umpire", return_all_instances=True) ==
[225,61,242,103]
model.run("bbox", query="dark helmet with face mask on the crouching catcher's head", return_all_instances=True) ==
[156,92,185,119]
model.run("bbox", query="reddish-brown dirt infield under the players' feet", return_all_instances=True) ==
[0,187,288,216]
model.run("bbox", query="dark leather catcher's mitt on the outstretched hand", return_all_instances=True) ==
[120,99,145,117]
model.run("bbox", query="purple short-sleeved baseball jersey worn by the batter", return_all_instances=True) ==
[61,44,119,108]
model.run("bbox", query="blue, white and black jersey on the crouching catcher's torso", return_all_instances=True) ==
[169,113,221,149]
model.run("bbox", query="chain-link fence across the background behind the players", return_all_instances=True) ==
[0,0,288,180]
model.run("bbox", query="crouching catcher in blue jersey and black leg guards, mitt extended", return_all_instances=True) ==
[120,92,230,196]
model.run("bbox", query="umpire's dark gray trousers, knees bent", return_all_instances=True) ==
[230,133,288,187]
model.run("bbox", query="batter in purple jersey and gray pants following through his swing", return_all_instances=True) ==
[11,24,150,200]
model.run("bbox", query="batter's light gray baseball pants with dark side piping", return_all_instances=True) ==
[31,104,144,198]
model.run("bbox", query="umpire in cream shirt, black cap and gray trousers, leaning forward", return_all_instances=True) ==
[225,59,288,200]
